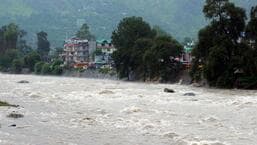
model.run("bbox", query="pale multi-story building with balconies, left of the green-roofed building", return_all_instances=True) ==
[62,38,90,66]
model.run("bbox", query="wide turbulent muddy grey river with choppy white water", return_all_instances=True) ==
[0,74,257,145]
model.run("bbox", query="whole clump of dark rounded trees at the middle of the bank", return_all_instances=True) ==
[112,17,182,81]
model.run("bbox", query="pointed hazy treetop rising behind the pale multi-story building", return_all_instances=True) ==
[76,24,95,40]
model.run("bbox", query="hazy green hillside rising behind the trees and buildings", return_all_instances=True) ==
[0,0,257,46]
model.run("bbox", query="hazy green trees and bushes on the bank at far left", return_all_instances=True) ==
[0,23,63,75]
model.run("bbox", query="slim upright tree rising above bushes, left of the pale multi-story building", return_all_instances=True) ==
[37,31,50,61]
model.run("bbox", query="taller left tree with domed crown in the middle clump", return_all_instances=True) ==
[112,17,155,79]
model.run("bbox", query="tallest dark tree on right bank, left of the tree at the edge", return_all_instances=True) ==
[191,0,248,88]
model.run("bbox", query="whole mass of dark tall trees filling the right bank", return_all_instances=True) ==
[189,0,257,88]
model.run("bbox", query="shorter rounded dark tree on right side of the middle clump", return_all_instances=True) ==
[144,36,183,82]
